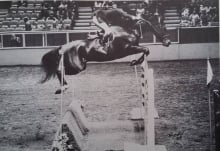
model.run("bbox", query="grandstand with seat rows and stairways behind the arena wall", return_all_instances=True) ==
[0,0,218,31]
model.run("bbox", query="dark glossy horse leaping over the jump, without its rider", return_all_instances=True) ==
[42,8,170,93]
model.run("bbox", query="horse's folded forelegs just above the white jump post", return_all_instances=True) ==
[127,46,150,66]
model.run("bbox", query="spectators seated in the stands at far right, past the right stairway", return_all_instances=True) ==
[180,0,219,27]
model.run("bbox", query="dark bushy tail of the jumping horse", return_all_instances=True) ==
[40,47,61,83]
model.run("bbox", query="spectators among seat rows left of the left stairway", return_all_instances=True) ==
[1,1,77,31]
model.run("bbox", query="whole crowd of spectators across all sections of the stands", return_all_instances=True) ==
[0,0,219,31]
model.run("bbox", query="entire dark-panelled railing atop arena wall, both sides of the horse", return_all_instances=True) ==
[0,27,219,49]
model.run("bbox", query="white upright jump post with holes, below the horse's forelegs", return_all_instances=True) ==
[127,57,166,151]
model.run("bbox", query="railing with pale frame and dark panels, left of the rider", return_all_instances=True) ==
[0,30,94,49]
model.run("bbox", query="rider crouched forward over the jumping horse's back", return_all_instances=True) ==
[90,8,137,54]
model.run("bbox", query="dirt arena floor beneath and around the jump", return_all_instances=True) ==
[0,60,219,151]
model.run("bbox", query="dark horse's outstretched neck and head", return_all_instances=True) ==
[135,17,171,47]
